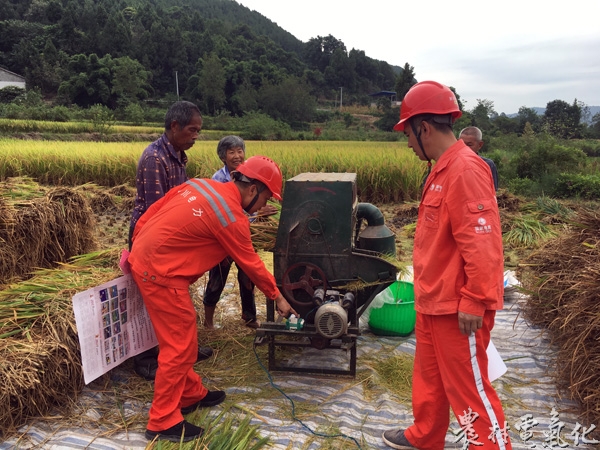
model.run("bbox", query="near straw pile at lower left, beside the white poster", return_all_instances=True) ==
[0,250,120,434]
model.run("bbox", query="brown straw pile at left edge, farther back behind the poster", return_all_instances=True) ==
[0,178,96,285]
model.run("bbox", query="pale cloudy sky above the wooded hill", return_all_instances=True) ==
[236,0,600,114]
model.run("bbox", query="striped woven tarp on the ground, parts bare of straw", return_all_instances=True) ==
[0,294,600,450]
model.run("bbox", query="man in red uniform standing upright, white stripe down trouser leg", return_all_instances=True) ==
[383,81,512,450]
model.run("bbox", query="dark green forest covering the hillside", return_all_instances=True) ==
[0,0,401,120]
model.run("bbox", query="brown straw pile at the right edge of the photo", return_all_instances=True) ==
[520,210,600,424]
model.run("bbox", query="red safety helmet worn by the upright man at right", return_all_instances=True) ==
[394,81,462,131]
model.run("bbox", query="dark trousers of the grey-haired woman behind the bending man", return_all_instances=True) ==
[202,257,256,322]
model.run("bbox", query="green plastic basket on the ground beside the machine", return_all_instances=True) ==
[369,281,417,336]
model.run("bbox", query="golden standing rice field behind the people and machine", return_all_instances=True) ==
[0,139,426,202]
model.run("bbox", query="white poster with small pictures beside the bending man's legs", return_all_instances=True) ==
[73,274,158,384]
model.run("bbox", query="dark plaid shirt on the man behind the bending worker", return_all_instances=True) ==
[130,134,188,231]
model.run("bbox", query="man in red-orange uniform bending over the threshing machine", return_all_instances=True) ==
[129,156,295,442]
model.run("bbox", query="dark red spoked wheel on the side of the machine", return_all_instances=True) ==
[281,263,327,306]
